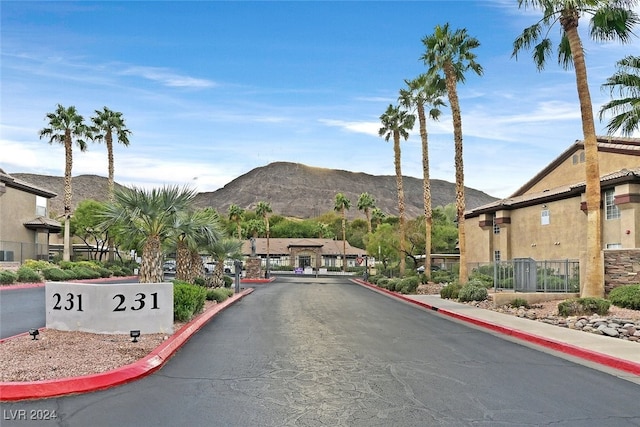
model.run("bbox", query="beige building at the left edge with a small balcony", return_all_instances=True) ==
[0,169,61,268]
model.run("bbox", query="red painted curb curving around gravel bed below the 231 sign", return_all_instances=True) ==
[0,288,253,402]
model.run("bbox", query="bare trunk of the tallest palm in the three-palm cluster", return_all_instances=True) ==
[444,64,468,284]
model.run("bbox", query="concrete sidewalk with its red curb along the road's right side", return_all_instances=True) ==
[354,280,640,376]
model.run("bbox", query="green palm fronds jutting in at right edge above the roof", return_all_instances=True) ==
[600,56,640,136]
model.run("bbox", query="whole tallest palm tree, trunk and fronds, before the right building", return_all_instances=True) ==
[512,0,638,297]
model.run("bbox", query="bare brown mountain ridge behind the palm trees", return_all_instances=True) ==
[11,162,497,218]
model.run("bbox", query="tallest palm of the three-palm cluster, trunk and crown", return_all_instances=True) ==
[420,23,483,283]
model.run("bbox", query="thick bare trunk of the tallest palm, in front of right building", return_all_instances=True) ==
[565,23,604,298]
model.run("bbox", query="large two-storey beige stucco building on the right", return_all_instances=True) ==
[465,137,640,287]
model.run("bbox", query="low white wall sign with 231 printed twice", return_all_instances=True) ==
[45,282,173,334]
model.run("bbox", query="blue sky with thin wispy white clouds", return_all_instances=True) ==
[0,0,640,201]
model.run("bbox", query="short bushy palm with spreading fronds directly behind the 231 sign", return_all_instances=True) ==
[101,186,197,283]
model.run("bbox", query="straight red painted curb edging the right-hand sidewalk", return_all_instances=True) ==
[352,279,640,375]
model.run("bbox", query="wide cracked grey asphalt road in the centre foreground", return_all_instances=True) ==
[0,277,640,427]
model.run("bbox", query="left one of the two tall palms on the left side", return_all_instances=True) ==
[40,104,91,261]
